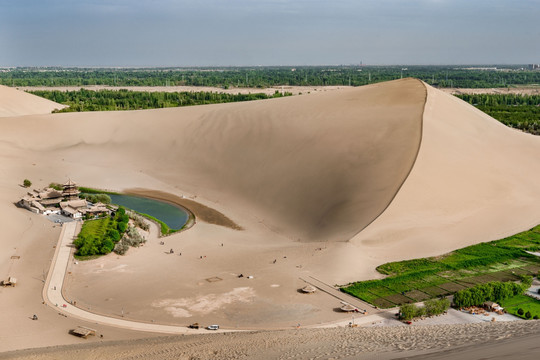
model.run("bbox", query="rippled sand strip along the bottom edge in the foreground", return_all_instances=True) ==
[0,321,540,360]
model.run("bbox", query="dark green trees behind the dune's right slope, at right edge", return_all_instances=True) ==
[456,94,540,135]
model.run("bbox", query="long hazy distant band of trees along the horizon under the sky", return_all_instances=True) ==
[0,65,540,88]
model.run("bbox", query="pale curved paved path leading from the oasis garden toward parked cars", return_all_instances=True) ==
[43,221,234,334]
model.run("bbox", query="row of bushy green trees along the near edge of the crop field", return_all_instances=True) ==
[454,276,532,308]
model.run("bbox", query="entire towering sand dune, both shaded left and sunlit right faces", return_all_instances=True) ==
[0,79,540,248]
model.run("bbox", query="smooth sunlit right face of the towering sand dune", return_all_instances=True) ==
[353,85,540,261]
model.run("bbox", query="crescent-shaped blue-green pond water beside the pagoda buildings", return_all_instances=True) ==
[109,195,189,230]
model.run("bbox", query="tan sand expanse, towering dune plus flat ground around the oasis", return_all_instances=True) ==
[0,79,540,358]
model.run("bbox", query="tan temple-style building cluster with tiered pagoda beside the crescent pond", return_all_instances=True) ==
[19,180,111,219]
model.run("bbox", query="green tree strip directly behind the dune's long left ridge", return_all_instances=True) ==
[30,89,291,112]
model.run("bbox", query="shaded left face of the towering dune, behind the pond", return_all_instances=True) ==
[0,79,426,241]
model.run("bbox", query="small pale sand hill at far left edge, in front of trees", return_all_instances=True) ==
[0,85,66,117]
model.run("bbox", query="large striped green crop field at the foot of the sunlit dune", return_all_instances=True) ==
[341,225,540,307]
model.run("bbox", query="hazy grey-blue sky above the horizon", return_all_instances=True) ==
[0,0,540,67]
